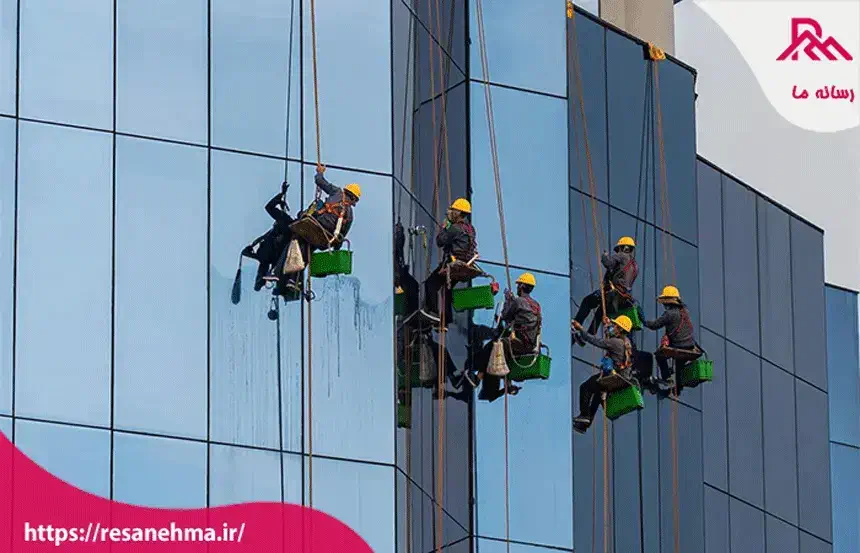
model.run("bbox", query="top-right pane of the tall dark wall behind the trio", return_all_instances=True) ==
[656,59,697,243]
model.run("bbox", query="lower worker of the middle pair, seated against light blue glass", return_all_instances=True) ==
[466,273,543,401]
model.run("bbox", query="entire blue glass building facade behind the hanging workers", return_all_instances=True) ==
[0,0,848,553]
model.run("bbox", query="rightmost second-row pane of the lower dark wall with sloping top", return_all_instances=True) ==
[796,380,831,540]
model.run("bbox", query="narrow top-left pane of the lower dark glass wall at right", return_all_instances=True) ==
[697,162,726,334]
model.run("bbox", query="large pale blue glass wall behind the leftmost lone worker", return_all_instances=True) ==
[0,0,396,551]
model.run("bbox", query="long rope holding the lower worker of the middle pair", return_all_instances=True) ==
[475,0,512,553]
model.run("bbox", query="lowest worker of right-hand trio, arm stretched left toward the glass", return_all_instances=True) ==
[571,315,633,433]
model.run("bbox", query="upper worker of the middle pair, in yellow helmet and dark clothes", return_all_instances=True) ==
[421,198,478,327]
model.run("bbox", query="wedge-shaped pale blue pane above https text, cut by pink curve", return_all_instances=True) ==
[15,420,110,497]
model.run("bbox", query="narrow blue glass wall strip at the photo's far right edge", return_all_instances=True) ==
[826,286,860,553]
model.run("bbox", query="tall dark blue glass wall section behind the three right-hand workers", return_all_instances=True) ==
[568,12,704,553]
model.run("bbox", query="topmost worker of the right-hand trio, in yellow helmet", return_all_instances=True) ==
[574,236,639,346]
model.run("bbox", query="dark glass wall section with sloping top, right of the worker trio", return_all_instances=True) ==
[697,159,832,553]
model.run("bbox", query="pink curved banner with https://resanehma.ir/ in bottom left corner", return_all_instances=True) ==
[0,432,372,553]
